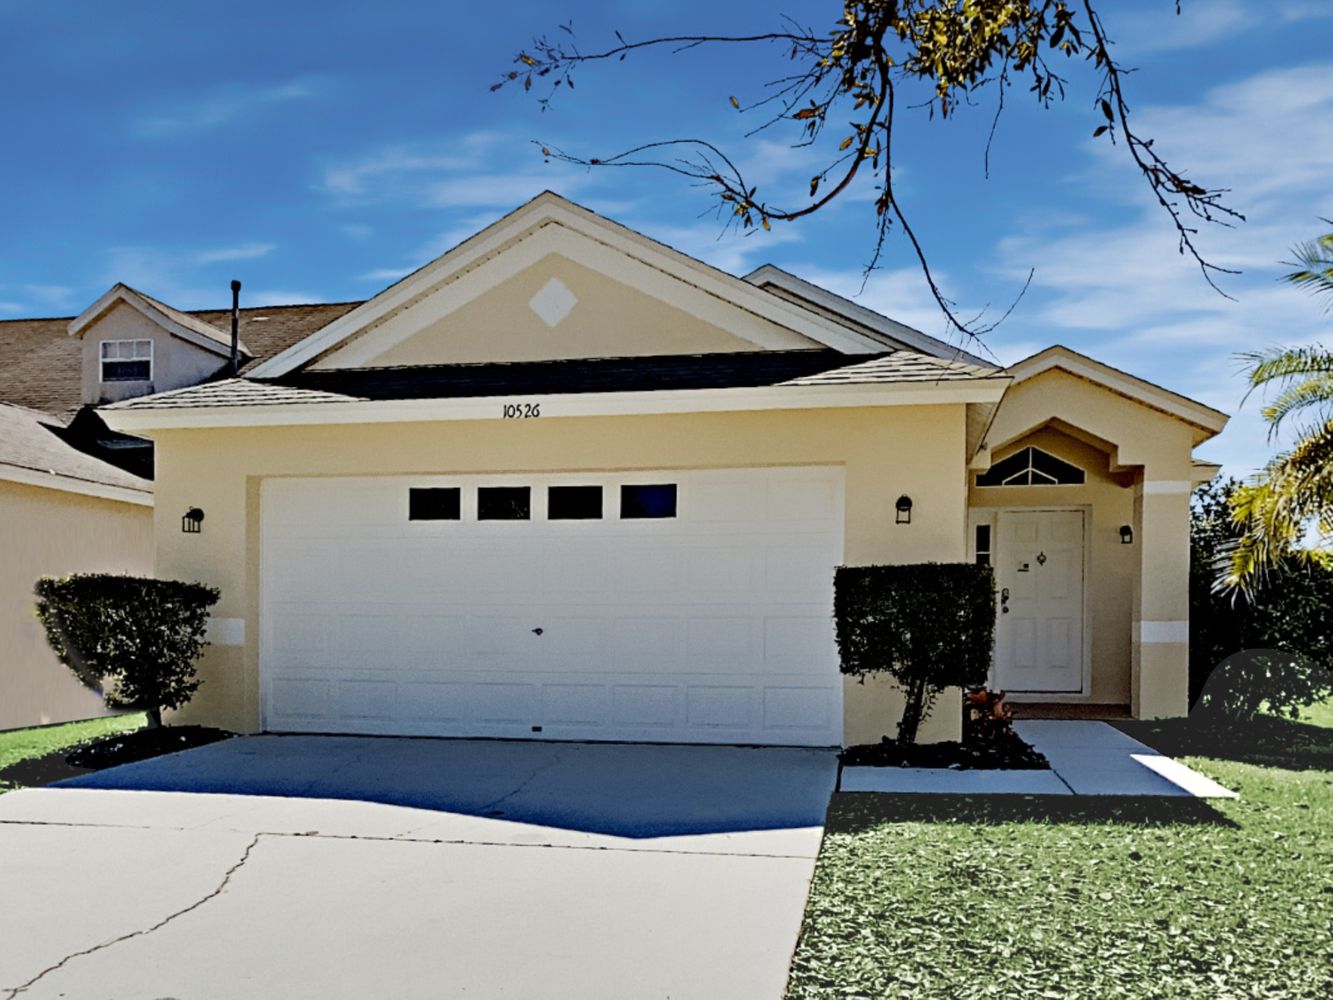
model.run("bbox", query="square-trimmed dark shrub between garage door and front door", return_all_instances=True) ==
[833,563,996,744]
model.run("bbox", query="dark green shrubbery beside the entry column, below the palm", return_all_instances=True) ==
[1189,479,1333,721]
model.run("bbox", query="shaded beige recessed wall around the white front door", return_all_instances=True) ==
[969,428,1137,705]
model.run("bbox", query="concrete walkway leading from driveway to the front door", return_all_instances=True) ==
[842,719,1236,799]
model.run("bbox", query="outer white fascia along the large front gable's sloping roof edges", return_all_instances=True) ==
[251,192,882,379]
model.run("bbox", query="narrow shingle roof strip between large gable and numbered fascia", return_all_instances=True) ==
[108,351,996,409]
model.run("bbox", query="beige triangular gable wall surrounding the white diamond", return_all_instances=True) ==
[323,253,820,368]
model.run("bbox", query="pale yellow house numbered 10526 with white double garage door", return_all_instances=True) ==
[88,193,1226,745]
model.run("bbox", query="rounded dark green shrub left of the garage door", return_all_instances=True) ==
[36,573,219,727]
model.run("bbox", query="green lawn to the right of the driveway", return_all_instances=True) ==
[788,705,1333,999]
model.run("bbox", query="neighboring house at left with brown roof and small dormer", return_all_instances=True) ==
[0,285,353,729]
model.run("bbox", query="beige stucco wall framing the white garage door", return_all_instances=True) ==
[155,405,966,743]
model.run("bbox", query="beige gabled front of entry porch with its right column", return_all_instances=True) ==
[972,369,1210,719]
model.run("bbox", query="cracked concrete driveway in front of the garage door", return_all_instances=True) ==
[0,736,836,1000]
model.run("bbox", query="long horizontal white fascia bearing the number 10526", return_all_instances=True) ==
[99,377,1009,433]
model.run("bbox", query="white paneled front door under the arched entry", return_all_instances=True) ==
[993,511,1084,693]
